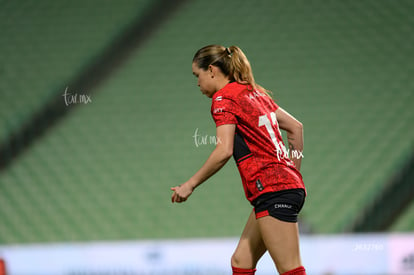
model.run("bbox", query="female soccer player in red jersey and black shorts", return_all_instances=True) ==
[171,45,306,275]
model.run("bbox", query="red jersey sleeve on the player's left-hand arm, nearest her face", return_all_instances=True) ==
[211,96,237,127]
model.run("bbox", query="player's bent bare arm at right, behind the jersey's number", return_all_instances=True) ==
[276,107,303,170]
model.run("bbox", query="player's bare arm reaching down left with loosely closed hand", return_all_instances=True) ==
[171,124,236,203]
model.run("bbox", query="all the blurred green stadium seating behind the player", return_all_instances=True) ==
[0,0,414,243]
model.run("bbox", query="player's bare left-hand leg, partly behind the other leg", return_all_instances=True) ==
[231,211,266,268]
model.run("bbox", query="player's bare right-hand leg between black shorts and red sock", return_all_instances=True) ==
[257,216,302,273]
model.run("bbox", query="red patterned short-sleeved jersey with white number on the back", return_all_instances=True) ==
[211,82,305,202]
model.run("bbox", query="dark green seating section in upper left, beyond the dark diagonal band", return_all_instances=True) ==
[0,0,154,147]
